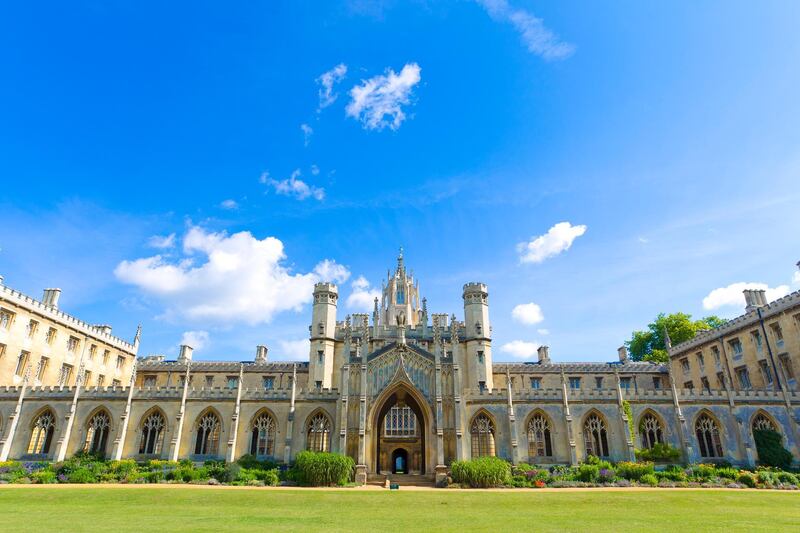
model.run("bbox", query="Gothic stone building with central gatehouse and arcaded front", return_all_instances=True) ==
[0,253,800,482]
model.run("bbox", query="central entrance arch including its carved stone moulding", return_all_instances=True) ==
[367,382,435,474]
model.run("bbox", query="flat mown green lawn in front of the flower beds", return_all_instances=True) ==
[0,486,800,532]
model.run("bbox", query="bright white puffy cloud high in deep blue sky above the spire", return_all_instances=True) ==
[345,63,421,131]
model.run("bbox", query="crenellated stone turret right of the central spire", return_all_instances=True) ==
[463,283,494,390]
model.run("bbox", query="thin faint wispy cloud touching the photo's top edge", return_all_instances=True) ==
[477,0,575,60]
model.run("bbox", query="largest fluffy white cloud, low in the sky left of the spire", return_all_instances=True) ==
[114,226,344,325]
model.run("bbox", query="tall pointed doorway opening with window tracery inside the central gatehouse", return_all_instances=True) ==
[373,387,427,475]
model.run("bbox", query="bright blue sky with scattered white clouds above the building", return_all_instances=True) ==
[0,0,800,361]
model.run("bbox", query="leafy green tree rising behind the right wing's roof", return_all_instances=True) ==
[625,313,725,363]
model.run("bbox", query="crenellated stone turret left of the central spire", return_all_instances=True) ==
[308,283,339,389]
